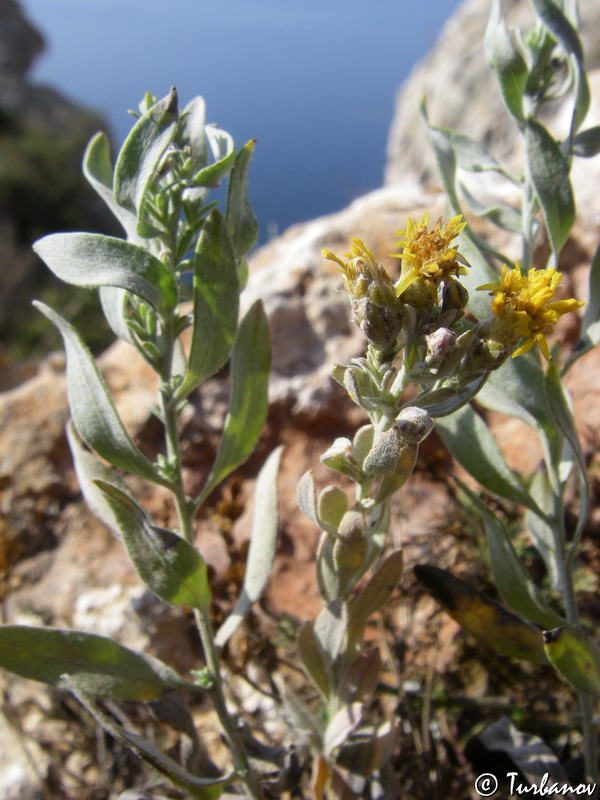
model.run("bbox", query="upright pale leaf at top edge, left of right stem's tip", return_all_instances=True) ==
[484,0,529,120]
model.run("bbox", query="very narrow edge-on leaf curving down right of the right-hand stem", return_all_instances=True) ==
[545,360,590,550]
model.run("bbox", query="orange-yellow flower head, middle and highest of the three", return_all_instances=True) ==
[390,214,468,304]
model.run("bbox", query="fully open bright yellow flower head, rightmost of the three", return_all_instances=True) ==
[478,263,583,359]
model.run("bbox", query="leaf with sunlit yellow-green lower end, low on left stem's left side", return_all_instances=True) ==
[94,480,211,611]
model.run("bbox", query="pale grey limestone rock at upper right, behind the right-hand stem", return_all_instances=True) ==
[385,0,600,224]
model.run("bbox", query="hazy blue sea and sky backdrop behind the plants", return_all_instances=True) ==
[22,0,458,241]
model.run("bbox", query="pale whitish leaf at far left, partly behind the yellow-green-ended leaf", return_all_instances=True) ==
[66,420,133,538]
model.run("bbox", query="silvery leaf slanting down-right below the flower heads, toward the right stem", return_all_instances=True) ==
[436,406,541,514]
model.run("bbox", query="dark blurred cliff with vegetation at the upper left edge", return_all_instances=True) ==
[0,0,117,357]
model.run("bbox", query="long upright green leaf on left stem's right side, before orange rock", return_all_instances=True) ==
[197,300,271,505]
